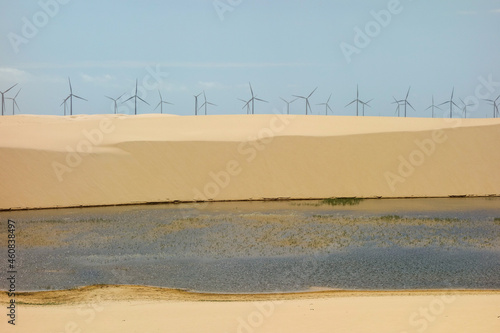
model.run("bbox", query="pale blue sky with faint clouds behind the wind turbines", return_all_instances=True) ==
[0,0,500,117]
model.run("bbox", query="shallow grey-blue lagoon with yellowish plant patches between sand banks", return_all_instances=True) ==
[0,198,500,293]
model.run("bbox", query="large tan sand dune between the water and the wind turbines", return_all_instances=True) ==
[0,115,500,209]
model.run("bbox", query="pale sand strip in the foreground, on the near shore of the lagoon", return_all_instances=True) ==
[0,287,500,333]
